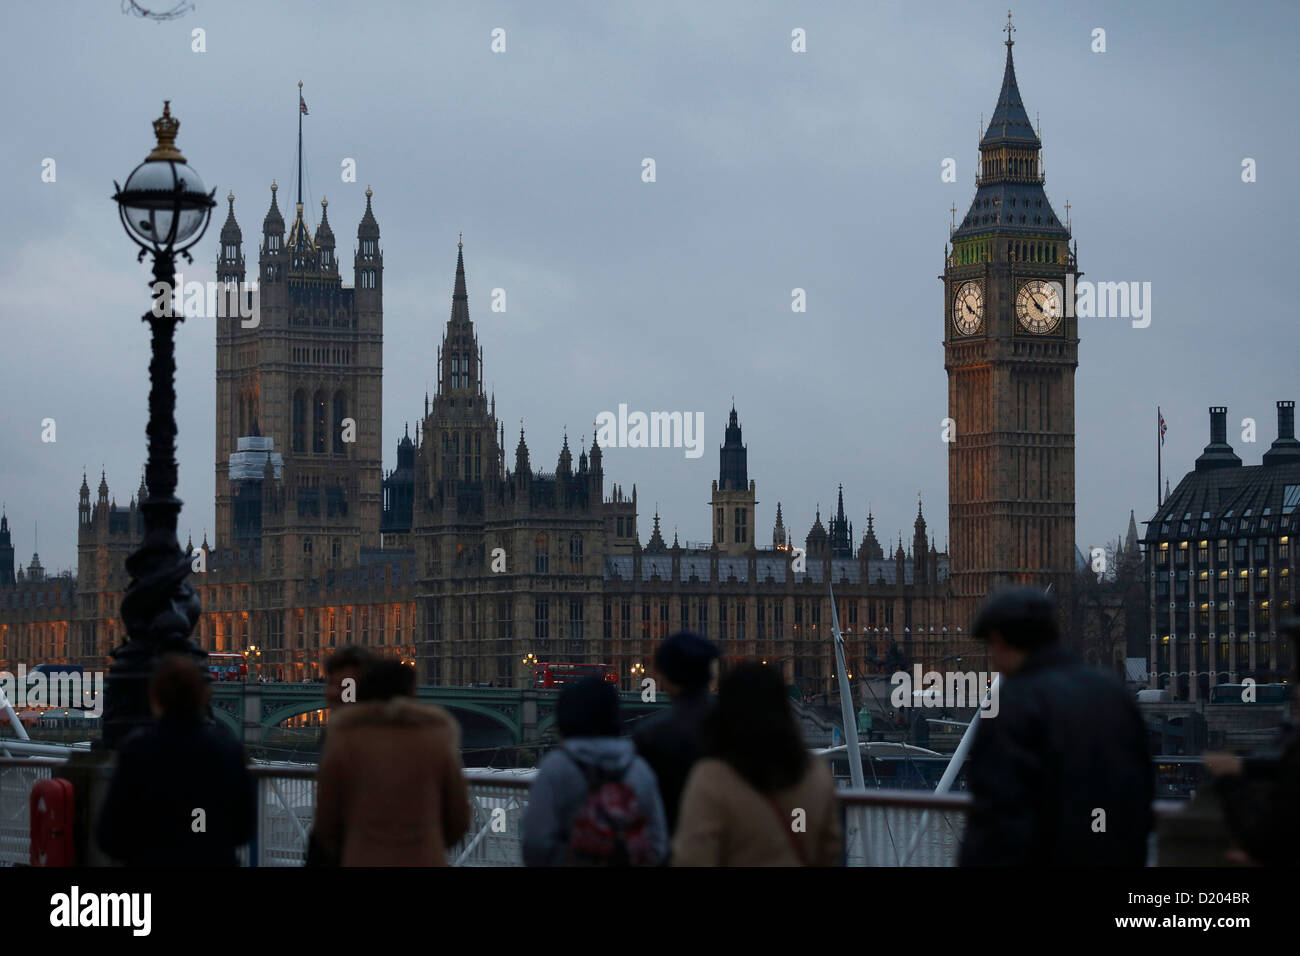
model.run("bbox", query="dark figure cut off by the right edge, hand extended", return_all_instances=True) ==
[1205,618,1300,866]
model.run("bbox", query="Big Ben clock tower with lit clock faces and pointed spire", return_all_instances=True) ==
[940,17,1080,613]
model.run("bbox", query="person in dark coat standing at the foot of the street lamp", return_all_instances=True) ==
[95,654,257,866]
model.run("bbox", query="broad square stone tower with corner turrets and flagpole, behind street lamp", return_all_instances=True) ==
[216,119,384,572]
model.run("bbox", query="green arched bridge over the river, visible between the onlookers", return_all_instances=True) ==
[212,682,668,748]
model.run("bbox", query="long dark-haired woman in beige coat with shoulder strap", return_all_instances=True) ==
[672,663,844,866]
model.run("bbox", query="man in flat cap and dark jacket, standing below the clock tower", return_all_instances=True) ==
[961,588,1154,866]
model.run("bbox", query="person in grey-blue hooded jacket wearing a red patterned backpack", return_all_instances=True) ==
[523,678,668,866]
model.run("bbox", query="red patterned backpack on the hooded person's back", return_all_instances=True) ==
[560,748,659,866]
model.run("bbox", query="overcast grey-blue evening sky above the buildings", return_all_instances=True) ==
[0,0,1300,570]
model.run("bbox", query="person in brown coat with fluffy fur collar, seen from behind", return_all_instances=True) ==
[315,661,469,866]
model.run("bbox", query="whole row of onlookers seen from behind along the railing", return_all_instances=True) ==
[95,589,1300,866]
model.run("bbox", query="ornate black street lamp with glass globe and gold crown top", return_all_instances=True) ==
[103,100,216,748]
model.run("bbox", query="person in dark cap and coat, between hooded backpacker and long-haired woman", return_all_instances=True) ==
[633,631,718,834]
